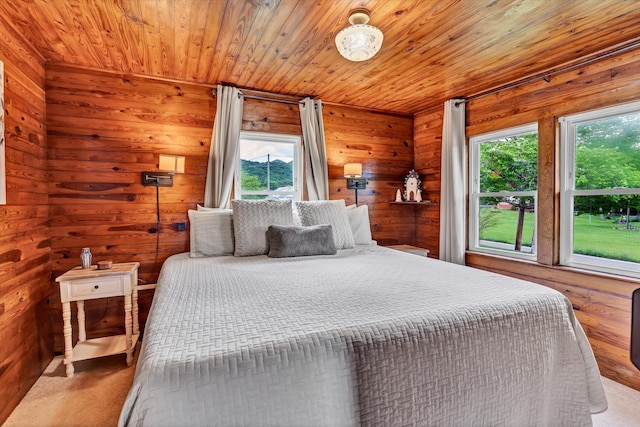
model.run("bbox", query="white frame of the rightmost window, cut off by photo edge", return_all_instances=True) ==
[558,102,640,277]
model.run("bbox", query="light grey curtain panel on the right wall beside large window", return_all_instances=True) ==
[440,99,467,265]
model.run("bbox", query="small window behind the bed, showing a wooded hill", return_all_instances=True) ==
[234,132,302,200]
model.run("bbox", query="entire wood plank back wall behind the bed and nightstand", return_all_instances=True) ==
[46,65,414,352]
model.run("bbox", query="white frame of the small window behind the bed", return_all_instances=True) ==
[233,131,302,201]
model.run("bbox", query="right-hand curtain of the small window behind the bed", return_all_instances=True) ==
[300,97,329,200]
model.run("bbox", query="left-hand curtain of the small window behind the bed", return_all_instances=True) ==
[204,85,244,208]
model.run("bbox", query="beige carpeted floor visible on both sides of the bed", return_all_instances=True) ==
[2,351,640,427]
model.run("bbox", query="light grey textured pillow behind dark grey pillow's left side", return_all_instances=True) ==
[231,199,293,256]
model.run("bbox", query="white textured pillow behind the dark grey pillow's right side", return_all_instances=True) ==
[296,199,355,249]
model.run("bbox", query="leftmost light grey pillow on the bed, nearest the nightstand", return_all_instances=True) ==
[187,208,233,258]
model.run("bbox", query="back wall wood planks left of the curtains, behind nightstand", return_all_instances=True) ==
[46,65,216,352]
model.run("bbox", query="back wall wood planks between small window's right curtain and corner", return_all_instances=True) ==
[323,105,415,245]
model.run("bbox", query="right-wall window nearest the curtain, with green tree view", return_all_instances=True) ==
[469,124,538,259]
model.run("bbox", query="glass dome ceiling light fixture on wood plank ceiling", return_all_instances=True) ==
[336,8,384,62]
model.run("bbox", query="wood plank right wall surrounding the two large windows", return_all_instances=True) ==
[415,46,640,390]
